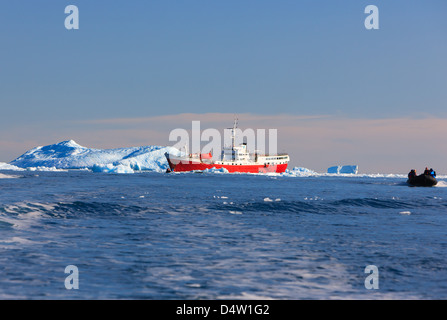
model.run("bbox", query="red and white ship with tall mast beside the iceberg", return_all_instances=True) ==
[165,120,290,173]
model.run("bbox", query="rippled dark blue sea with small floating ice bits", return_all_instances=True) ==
[0,170,447,300]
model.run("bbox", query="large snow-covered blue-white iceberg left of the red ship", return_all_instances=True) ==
[10,140,180,173]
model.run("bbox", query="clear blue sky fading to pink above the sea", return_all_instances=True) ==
[0,0,447,173]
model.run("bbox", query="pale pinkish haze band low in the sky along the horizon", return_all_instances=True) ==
[0,113,447,173]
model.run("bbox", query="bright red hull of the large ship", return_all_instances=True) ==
[168,158,287,173]
